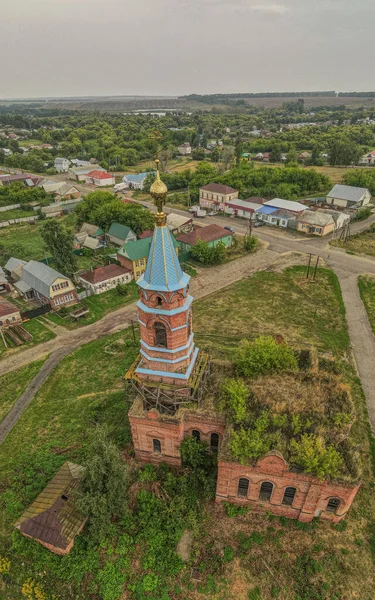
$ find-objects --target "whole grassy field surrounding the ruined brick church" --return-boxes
[0,267,375,600]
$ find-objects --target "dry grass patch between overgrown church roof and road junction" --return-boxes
[194,267,349,353]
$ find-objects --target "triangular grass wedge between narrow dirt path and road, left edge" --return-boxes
[0,357,47,421]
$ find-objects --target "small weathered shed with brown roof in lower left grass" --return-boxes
[15,461,87,556]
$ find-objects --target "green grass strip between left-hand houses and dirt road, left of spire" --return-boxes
[46,281,138,329]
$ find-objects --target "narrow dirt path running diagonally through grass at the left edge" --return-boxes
[0,346,73,444]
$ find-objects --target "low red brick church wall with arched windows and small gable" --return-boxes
[216,452,360,523]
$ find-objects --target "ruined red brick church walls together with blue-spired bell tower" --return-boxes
[125,161,359,522]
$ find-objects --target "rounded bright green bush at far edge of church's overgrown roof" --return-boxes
[234,336,298,377]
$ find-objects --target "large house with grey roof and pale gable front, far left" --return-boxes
[15,260,78,310]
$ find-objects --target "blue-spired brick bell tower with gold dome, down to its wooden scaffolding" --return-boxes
[125,160,209,415]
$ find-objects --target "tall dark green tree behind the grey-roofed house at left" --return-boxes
[40,219,77,277]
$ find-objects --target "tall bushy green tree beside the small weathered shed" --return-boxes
[77,427,130,542]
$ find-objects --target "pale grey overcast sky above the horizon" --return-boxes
[0,0,375,98]
